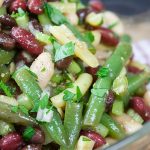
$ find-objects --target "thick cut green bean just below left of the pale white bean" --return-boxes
[12,67,42,108]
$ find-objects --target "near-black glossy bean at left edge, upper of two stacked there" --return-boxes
[0,15,17,28]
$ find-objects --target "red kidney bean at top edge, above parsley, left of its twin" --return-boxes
[9,0,27,12]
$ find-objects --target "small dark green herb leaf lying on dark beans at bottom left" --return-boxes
[23,127,35,141]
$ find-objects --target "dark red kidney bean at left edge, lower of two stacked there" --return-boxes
[0,32,15,50]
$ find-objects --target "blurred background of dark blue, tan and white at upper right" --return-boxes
[83,0,150,66]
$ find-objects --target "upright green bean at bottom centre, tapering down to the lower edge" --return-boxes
[64,102,83,150]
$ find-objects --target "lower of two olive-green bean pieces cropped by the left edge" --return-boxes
[0,65,10,82]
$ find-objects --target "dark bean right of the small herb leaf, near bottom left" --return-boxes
[30,128,45,144]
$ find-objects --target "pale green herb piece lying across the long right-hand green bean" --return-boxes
[91,89,108,98]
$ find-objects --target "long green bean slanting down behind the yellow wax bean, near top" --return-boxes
[44,3,96,53]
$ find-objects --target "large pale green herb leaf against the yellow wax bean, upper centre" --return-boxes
[55,42,75,62]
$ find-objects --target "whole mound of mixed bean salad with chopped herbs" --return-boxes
[0,0,150,150]
